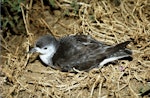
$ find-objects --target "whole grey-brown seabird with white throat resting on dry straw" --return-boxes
[29,35,132,72]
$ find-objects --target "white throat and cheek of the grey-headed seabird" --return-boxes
[39,45,56,66]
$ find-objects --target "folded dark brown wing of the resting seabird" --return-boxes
[53,35,107,71]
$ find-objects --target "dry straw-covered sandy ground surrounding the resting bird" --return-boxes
[0,0,150,98]
